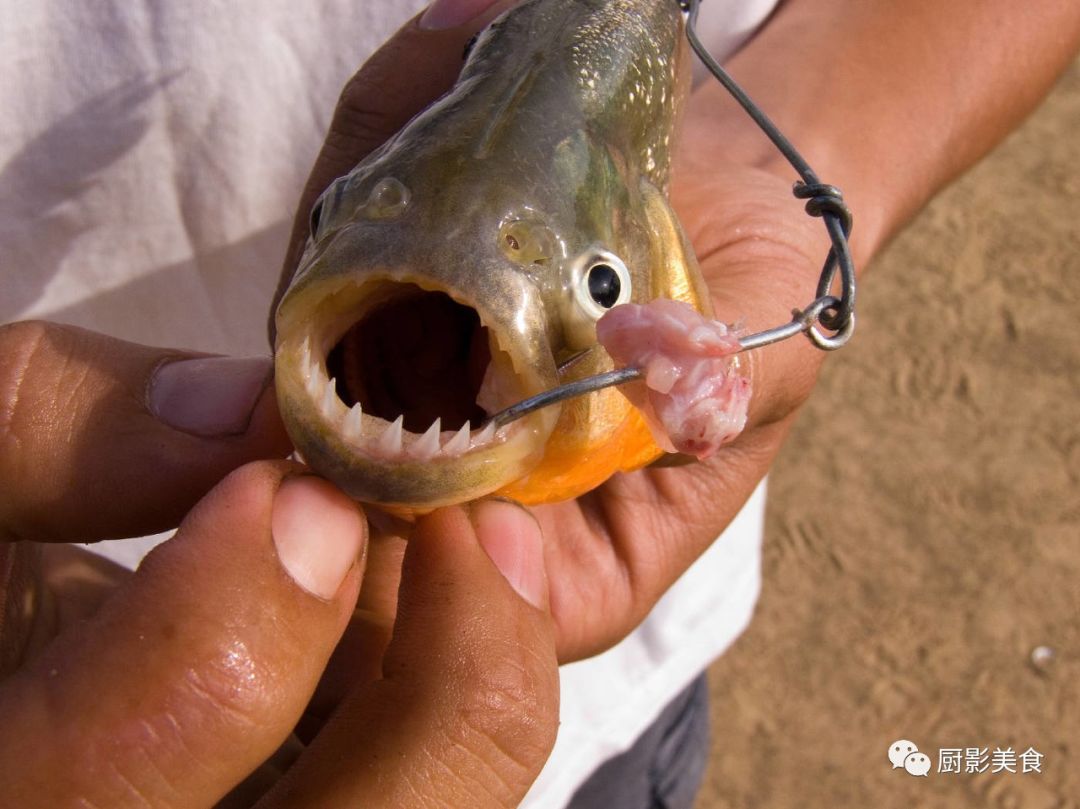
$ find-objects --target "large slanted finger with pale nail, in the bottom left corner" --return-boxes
[0,462,365,809]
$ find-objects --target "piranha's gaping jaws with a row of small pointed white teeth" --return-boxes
[275,271,559,513]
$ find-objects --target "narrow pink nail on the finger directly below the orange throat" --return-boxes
[469,500,548,609]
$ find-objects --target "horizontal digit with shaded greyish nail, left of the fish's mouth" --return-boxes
[0,323,289,542]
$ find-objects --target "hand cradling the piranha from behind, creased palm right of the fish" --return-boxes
[270,3,827,661]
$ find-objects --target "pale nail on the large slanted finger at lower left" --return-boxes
[270,475,367,601]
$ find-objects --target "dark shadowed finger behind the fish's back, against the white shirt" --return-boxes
[270,0,516,330]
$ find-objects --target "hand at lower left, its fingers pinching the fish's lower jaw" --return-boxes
[0,323,557,809]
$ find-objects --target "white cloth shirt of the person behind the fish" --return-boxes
[0,0,774,807]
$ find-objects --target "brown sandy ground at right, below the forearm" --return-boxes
[698,62,1080,809]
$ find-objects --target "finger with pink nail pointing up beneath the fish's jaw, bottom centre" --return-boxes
[260,501,558,807]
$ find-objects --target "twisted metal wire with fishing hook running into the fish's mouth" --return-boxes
[488,0,855,429]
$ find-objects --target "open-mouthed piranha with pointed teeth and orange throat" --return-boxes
[275,0,707,511]
